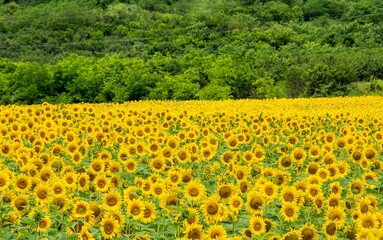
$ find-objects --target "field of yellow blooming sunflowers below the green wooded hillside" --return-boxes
[0,97,383,240]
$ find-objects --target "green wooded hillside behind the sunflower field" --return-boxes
[0,0,383,104]
